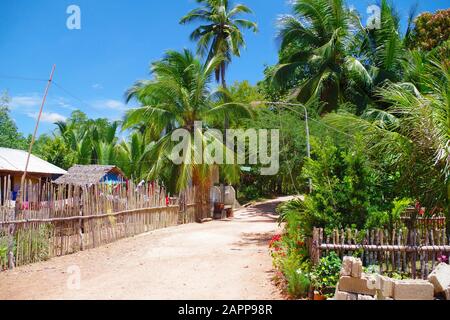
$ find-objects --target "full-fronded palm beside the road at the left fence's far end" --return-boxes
[123,50,250,220]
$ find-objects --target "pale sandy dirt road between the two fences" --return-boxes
[0,198,288,300]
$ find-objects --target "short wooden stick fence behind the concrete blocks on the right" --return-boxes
[309,227,450,279]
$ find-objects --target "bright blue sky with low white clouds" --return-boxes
[0,0,450,134]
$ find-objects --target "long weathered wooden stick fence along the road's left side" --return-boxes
[0,178,197,270]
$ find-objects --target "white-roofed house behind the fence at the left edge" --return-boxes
[0,148,67,200]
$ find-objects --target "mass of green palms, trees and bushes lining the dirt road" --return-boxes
[0,0,450,298]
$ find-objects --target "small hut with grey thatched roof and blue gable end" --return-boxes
[55,165,125,186]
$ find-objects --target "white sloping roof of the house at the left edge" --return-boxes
[0,148,67,175]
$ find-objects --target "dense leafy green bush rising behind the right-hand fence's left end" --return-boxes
[302,139,379,233]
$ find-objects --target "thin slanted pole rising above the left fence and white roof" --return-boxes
[8,65,56,269]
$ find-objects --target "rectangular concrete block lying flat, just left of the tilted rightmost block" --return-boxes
[394,280,434,300]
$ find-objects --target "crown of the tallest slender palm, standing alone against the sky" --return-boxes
[180,0,258,87]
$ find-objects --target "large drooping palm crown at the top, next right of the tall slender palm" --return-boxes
[273,0,371,113]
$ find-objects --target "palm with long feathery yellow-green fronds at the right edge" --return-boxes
[325,60,450,212]
